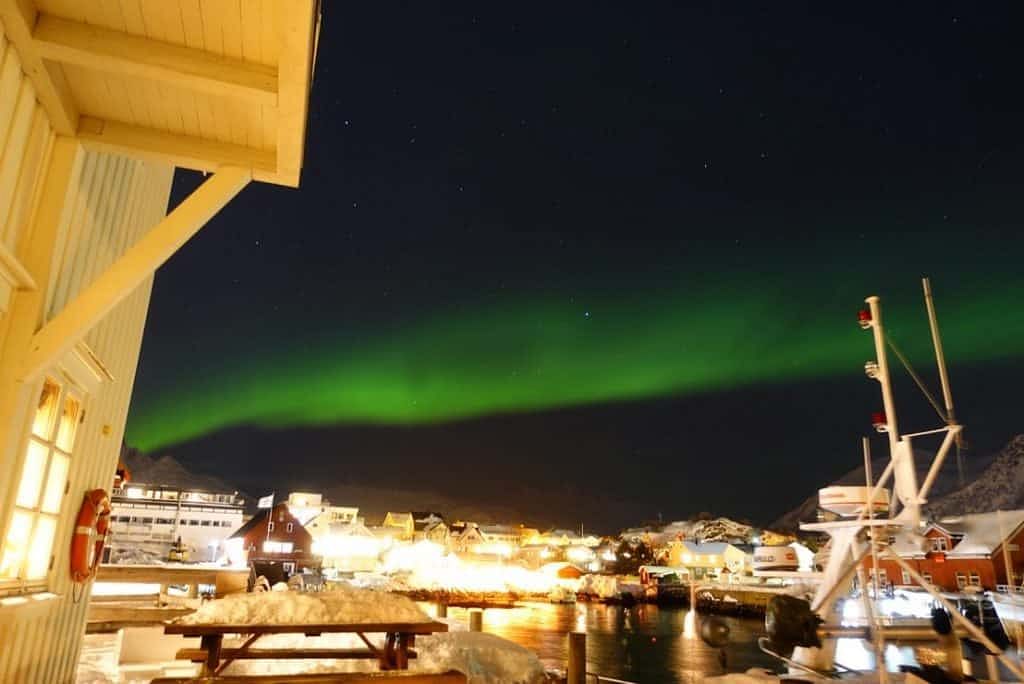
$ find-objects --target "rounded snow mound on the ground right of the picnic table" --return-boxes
[414,632,546,684]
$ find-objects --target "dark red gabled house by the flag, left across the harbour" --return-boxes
[230,503,321,575]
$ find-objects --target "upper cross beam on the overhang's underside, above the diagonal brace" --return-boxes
[33,14,278,106]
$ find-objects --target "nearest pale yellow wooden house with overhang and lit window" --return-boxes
[0,0,318,684]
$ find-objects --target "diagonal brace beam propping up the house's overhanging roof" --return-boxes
[20,167,252,380]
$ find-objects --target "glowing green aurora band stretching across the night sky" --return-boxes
[127,273,1024,451]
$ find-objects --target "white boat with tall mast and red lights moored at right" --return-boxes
[701,279,1024,681]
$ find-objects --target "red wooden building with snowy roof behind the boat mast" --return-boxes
[864,510,1024,591]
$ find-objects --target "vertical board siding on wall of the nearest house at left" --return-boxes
[0,18,173,684]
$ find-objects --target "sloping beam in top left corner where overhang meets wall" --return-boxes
[0,0,79,135]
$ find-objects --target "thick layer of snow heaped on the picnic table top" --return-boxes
[178,587,430,625]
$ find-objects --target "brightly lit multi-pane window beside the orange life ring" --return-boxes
[0,377,82,589]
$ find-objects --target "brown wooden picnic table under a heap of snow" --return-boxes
[164,622,447,677]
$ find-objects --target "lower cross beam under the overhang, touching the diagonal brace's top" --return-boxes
[78,117,276,182]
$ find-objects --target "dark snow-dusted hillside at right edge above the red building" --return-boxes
[928,434,1024,515]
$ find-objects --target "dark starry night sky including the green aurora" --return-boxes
[127,1,1024,528]
